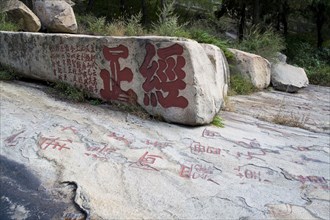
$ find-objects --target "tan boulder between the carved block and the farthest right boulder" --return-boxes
[230,49,271,89]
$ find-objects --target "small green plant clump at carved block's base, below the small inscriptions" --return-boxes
[51,82,88,102]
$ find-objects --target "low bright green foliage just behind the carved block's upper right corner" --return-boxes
[190,29,234,59]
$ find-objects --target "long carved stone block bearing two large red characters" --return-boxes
[0,32,224,125]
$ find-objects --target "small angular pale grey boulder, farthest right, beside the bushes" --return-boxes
[271,63,309,92]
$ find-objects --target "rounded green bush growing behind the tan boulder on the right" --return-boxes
[234,25,285,62]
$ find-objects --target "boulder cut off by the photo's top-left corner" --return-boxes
[0,0,41,32]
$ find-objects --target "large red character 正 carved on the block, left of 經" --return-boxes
[100,45,136,102]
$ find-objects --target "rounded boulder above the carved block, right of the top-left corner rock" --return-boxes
[33,0,78,33]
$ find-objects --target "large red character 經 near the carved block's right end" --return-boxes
[140,43,188,108]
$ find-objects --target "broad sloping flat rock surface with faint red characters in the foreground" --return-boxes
[0,82,330,220]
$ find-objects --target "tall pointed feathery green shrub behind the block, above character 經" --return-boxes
[151,2,189,38]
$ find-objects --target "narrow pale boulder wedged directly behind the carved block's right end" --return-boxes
[201,44,229,105]
